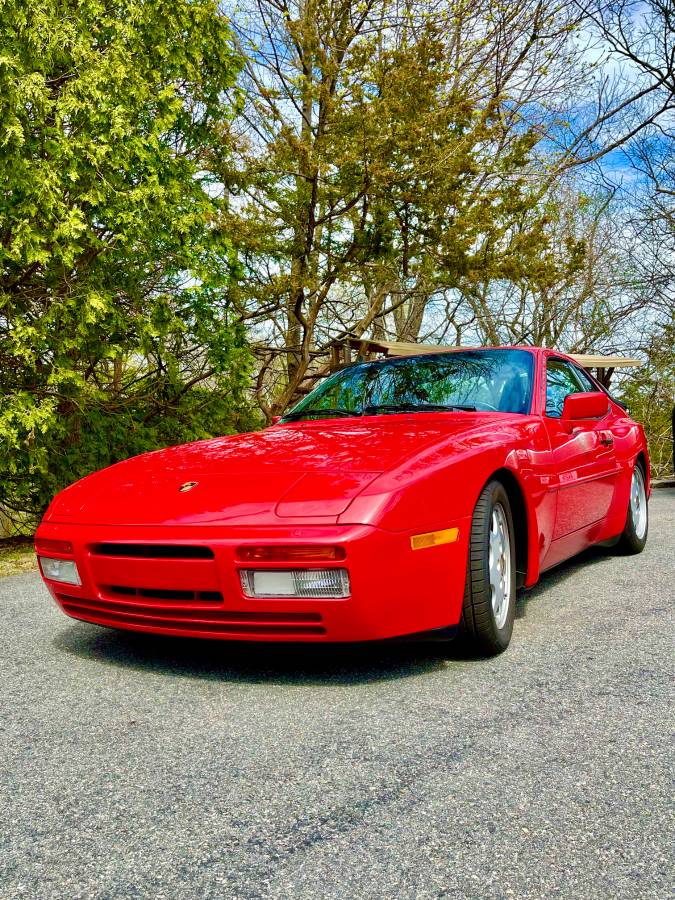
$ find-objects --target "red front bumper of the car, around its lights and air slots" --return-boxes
[36,522,468,642]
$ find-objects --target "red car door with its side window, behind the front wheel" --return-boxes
[544,356,617,541]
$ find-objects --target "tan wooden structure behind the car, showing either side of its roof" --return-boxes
[330,338,643,388]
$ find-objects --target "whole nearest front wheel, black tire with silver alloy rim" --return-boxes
[460,481,516,655]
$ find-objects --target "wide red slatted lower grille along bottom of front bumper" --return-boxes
[58,594,326,639]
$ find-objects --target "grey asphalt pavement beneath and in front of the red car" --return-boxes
[0,490,675,900]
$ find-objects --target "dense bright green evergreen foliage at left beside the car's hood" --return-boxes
[0,0,254,525]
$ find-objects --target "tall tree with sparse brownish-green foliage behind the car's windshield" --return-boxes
[223,0,567,417]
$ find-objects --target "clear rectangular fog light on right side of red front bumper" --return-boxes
[239,569,349,600]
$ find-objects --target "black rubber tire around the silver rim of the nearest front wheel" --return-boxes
[459,480,516,656]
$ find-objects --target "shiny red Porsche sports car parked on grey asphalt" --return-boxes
[35,347,650,653]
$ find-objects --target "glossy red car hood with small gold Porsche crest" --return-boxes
[45,413,492,525]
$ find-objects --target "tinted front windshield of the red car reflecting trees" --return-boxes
[284,350,534,421]
